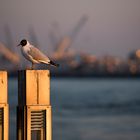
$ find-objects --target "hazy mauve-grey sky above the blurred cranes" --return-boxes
[0,0,140,56]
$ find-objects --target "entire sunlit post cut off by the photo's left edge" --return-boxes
[0,71,9,140]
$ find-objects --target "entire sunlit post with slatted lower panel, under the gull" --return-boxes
[17,70,52,140]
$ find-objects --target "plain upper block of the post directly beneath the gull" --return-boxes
[18,70,50,106]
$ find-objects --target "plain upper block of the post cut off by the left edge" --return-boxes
[0,71,7,104]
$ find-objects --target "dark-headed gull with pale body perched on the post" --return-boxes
[18,39,59,69]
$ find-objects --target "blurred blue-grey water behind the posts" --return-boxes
[9,79,140,140]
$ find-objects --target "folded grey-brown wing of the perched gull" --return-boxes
[28,46,50,63]
